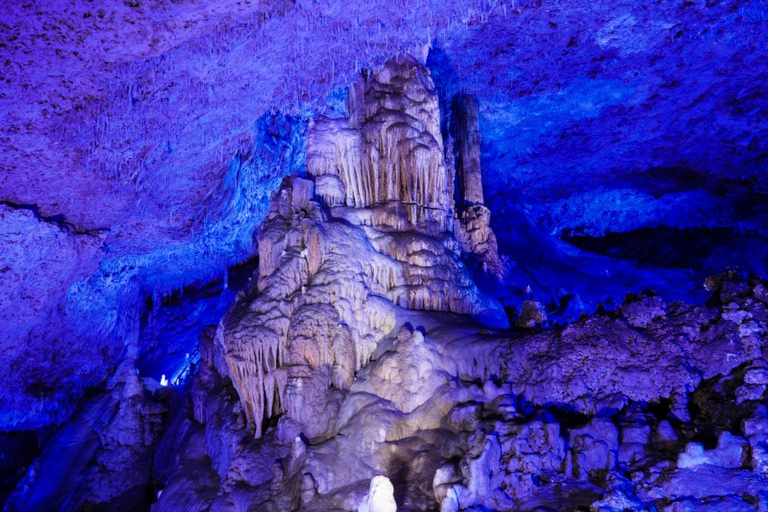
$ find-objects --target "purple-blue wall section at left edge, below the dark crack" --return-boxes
[0,204,112,429]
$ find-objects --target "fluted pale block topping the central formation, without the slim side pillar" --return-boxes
[307,58,453,233]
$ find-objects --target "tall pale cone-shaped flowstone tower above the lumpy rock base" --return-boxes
[218,59,506,437]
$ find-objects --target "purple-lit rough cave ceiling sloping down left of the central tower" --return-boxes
[0,1,508,432]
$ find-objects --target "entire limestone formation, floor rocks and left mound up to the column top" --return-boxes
[5,50,768,512]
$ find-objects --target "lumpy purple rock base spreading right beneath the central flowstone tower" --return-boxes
[130,273,768,511]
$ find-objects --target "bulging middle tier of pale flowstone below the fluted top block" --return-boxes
[217,174,505,438]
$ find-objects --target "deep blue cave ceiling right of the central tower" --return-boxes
[428,1,768,238]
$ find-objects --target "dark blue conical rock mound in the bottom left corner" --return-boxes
[4,364,166,512]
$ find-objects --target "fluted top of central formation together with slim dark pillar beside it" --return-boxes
[307,58,504,278]
